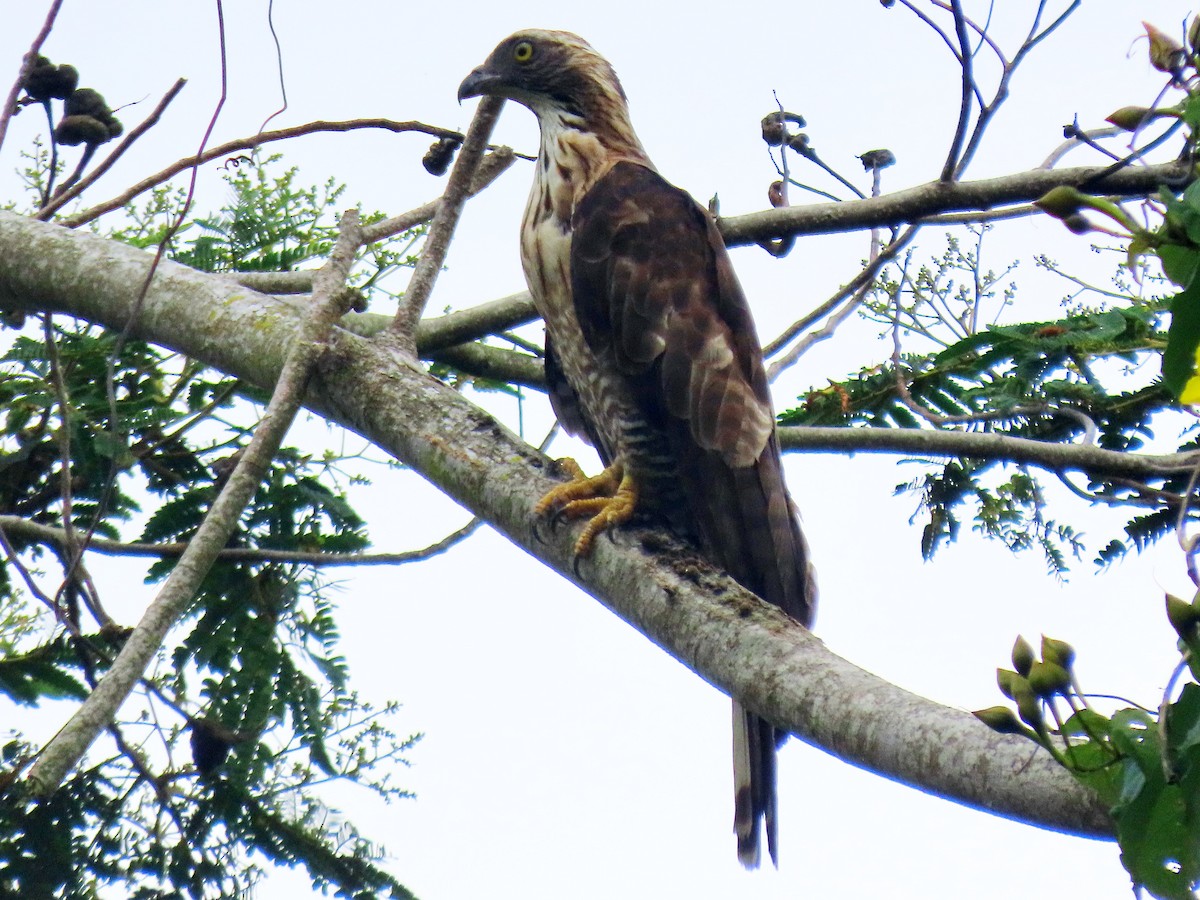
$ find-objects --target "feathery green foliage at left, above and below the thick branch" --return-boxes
[0,162,419,898]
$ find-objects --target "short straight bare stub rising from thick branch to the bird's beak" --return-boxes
[389,97,504,360]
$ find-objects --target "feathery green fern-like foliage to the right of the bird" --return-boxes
[780,229,1193,575]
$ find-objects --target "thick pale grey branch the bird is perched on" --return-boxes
[0,211,1110,836]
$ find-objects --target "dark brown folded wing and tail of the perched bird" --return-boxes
[571,162,816,864]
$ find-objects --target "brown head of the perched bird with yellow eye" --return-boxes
[458,29,625,121]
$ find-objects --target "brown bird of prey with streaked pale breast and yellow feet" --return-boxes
[458,30,816,866]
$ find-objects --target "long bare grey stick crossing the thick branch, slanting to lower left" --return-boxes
[28,210,361,797]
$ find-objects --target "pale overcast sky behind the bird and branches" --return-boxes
[7,0,1189,900]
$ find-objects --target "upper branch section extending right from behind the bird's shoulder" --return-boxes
[718,162,1193,247]
